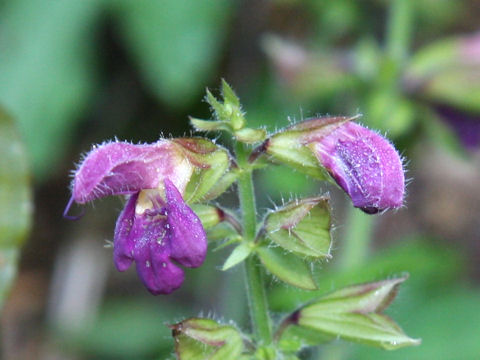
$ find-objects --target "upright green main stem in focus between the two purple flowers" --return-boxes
[235,142,272,345]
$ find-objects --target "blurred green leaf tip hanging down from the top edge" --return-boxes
[111,0,232,108]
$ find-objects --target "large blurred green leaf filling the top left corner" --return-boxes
[0,0,102,177]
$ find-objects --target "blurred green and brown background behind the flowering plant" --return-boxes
[0,0,480,360]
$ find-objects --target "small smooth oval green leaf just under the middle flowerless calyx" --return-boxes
[256,247,317,290]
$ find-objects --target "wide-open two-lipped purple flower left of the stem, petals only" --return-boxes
[67,140,207,295]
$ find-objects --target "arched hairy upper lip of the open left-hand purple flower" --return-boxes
[72,140,193,204]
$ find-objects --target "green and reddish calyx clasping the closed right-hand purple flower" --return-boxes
[257,116,359,180]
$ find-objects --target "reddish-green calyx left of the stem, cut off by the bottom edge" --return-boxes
[170,318,244,360]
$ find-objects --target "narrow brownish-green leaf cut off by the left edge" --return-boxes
[0,108,32,309]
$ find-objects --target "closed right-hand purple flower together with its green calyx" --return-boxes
[263,117,405,214]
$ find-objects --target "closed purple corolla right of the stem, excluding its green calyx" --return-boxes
[308,122,405,214]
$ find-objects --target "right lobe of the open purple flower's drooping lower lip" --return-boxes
[165,179,207,267]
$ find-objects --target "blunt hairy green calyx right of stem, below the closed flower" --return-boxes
[264,197,332,259]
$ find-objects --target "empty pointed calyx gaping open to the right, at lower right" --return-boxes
[288,276,420,350]
